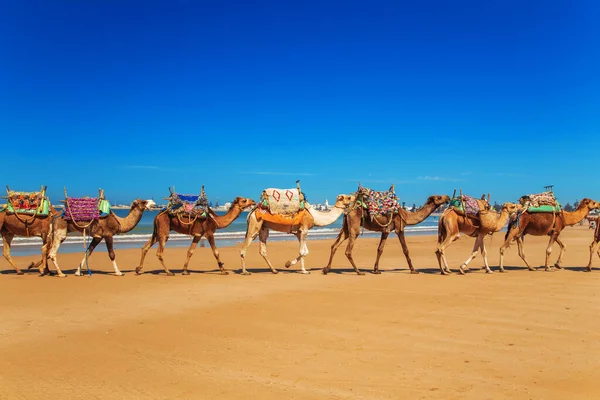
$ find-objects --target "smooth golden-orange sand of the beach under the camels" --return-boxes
[0,227,600,400]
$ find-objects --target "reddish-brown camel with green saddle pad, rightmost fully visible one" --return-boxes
[500,199,600,272]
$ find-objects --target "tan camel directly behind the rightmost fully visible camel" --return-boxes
[435,203,522,275]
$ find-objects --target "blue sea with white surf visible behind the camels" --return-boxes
[0,210,438,256]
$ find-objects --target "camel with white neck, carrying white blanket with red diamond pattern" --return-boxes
[240,194,354,275]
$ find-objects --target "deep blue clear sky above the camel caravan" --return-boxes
[0,0,600,204]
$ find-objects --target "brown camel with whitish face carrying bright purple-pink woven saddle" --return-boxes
[48,198,155,278]
